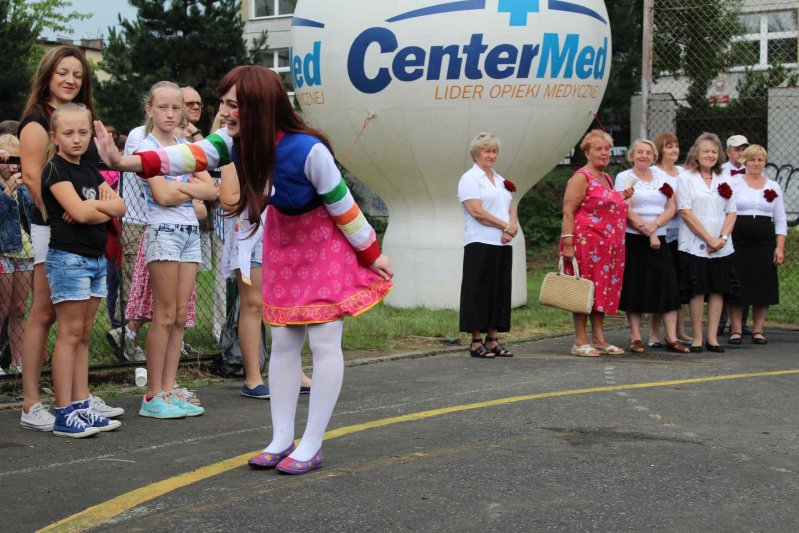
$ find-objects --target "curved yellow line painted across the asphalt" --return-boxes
[39,369,799,531]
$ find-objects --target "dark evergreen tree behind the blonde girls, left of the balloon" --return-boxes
[96,0,266,131]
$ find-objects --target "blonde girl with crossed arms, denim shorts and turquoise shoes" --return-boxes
[139,81,218,418]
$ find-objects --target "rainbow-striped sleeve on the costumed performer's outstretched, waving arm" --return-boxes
[137,128,233,178]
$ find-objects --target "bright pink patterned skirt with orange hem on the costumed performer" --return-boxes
[263,206,393,326]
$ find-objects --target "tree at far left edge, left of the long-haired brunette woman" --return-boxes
[0,0,89,120]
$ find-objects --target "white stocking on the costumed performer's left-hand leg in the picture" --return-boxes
[264,326,306,453]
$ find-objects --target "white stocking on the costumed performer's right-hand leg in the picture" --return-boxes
[294,320,344,461]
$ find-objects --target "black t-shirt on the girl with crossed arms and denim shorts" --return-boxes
[42,155,108,257]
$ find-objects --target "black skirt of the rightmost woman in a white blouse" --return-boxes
[727,216,780,307]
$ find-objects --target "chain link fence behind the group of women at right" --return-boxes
[644,0,799,324]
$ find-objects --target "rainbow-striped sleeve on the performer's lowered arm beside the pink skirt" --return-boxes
[321,174,380,266]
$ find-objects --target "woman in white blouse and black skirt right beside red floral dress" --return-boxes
[615,140,689,353]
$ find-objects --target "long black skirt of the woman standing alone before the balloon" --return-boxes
[460,242,513,333]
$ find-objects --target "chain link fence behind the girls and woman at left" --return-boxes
[0,164,231,374]
